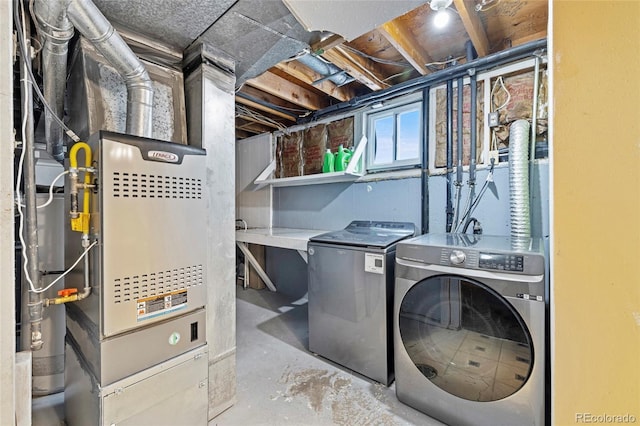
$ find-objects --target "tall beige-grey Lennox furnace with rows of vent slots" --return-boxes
[65,132,208,425]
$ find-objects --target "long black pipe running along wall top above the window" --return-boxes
[304,38,547,124]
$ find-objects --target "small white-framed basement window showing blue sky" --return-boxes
[366,102,422,171]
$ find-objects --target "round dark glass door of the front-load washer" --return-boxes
[398,275,534,402]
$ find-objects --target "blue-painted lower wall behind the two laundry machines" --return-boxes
[266,160,549,297]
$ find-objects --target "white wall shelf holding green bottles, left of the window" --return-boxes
[253,136,367,188]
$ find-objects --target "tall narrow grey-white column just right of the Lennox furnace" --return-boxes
[185,53,236,419]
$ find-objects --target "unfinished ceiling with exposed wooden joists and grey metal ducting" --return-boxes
[95,0,548,139]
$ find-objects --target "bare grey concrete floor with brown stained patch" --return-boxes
[32,287,442,426]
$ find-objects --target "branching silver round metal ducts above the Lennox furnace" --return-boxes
[35,0,153,161]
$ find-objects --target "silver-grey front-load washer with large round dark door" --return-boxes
[394,234,546,426]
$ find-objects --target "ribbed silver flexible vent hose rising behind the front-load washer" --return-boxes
[509,120,531,239]
